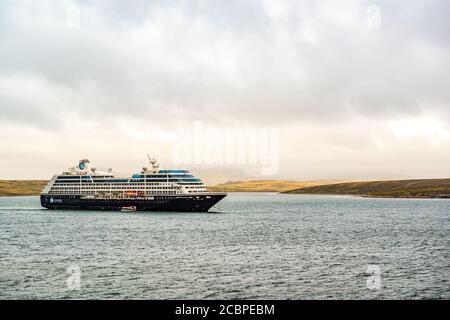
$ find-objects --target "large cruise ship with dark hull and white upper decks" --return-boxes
[41,157,227,212]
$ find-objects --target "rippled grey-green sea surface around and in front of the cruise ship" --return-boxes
[0,194,450,299]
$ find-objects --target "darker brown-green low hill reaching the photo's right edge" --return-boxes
[285,179,450,198]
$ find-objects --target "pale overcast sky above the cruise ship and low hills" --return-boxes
[0,0,450,179]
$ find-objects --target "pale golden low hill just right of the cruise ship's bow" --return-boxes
[207,180,348,192]
